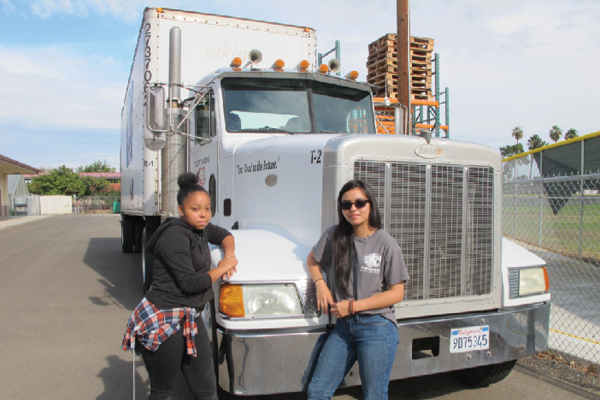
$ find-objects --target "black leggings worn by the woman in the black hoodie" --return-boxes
[136,318,218,400]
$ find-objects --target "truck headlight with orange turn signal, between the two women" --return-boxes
[219,284,304,318]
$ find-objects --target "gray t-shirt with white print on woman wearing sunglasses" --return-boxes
[312,226,409,323]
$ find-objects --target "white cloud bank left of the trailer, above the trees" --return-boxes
[0,46,126,130]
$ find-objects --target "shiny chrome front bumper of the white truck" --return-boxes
[217,303,550,395]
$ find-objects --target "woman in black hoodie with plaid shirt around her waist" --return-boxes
[122,173,237,400]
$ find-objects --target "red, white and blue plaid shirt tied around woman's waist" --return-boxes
[121,297,198,357]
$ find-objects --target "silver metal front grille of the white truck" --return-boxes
[354,161,494,300]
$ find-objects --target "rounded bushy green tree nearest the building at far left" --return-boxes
[28,165,85,196]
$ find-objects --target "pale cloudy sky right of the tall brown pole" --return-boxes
[404,0,600,149]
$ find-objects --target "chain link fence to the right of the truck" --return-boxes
[503,134,600,363]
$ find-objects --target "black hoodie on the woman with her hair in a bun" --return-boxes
[146,218,230,309]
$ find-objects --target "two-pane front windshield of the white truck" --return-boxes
[222,78,375,134]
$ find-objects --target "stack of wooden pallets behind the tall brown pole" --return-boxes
[367,33,434,101]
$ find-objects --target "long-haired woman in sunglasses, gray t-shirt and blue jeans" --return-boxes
[307,180,409,400]
